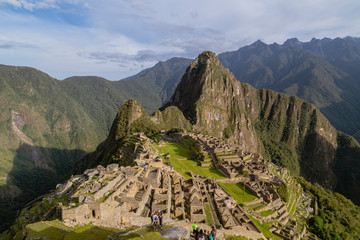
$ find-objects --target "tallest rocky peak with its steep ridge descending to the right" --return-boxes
[165,52,359,202]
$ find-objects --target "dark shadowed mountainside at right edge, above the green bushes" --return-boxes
[299,132,360,205]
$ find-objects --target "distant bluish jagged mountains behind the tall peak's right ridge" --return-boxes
[219,38,360,139]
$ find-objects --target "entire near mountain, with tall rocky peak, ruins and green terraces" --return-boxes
[1,52,360,239]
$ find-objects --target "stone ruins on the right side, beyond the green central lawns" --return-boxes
[183,134,299,235]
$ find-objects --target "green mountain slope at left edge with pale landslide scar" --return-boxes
[0,65,103,230]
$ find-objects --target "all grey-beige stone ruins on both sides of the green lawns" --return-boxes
[56,134,312,238]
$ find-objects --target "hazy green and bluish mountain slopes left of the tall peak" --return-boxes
[0,58,190,232]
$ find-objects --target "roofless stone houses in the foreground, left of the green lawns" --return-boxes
[57,161,263,238]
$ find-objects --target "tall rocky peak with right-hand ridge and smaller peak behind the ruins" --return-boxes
[77,49,360,207]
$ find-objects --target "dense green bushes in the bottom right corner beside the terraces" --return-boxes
[297,177,360,239]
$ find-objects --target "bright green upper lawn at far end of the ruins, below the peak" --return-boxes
[155,142,226,179]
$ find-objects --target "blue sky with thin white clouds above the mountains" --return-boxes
[0,0,360,80]
